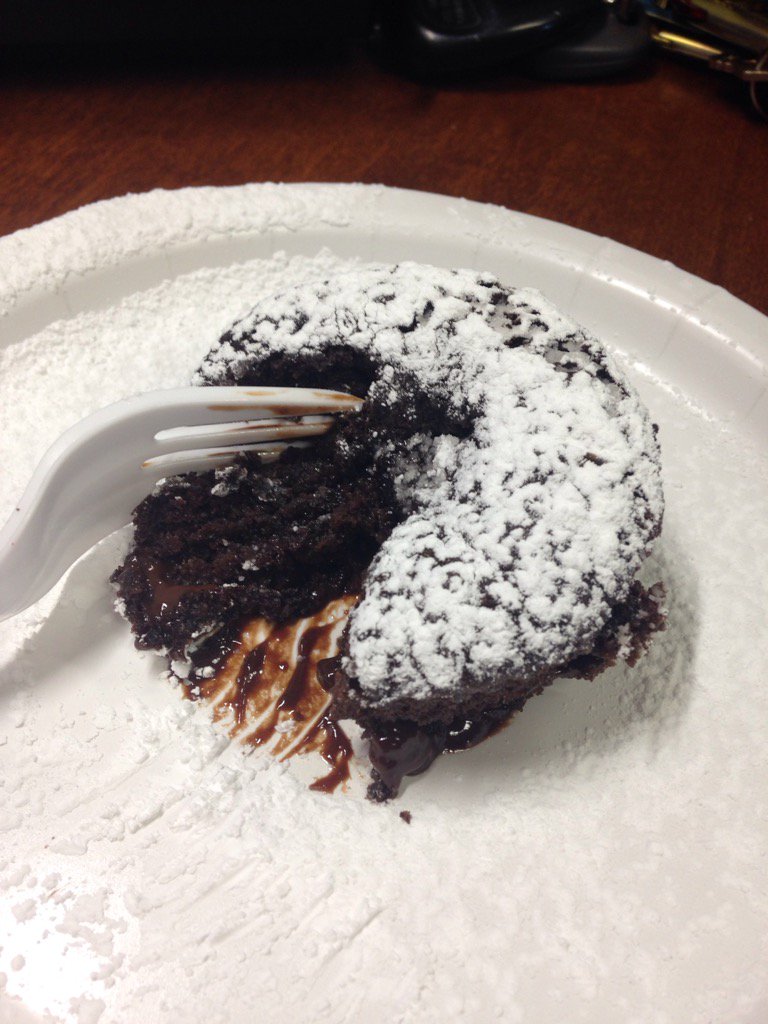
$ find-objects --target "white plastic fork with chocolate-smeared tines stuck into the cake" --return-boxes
[0,387,362,621]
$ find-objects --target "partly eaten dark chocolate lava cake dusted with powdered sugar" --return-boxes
[113,264,664,798]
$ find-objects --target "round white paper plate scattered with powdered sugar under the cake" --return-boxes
[0,185,768,1024]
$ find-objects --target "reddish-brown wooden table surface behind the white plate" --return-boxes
[0,46,768,312]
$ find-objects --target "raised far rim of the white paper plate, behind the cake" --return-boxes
[0,182,768,435]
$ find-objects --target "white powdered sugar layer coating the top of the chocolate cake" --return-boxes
[197,263,663,709]
